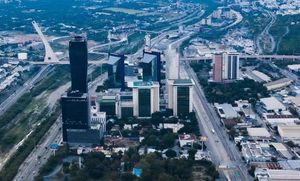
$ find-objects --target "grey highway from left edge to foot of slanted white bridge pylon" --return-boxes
[0,65,51,116]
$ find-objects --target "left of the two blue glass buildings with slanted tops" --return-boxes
[108,54,125,90]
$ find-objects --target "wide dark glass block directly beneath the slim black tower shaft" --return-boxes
[61,95,89,141]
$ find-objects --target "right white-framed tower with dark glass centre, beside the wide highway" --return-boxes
[168,79,195,116]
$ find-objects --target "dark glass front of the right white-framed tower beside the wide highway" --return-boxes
[177,87,190,115]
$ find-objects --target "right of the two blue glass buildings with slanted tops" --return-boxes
[141,51,161,83]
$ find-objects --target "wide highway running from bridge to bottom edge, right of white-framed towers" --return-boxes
[183,64,250,181]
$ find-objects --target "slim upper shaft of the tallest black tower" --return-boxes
[69,36,88,93]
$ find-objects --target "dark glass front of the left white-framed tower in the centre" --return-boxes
[138,89,151,117]
